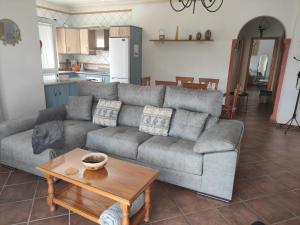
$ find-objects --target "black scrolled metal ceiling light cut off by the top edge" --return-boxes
[170,0,223,14]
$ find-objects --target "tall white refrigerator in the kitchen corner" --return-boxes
[109,38,130,83]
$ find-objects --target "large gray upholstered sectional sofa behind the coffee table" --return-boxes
[0,82,244,201]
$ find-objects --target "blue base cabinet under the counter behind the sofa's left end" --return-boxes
[45,83,79,108]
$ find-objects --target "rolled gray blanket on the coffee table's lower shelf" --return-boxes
[99,194,144,225]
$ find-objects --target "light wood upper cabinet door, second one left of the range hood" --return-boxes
[66,29,81,54]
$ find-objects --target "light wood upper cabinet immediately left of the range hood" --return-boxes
[79,29,96,55]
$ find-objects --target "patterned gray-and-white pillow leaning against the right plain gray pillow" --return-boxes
[139,105,173,136]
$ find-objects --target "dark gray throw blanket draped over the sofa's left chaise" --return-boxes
[32,107,66,154]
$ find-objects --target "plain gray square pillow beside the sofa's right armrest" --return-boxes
[169,109,208,141]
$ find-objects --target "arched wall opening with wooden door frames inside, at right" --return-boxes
[227,16,290,119]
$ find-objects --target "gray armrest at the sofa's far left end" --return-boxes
[0,116,37,142]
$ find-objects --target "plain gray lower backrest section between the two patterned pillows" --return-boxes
[118,105,144,127]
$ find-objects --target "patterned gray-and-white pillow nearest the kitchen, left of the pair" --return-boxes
[93,99,122,127]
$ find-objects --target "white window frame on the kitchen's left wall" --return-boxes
[38,17,59,76]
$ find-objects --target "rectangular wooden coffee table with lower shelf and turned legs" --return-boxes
[37,149,159,225]
